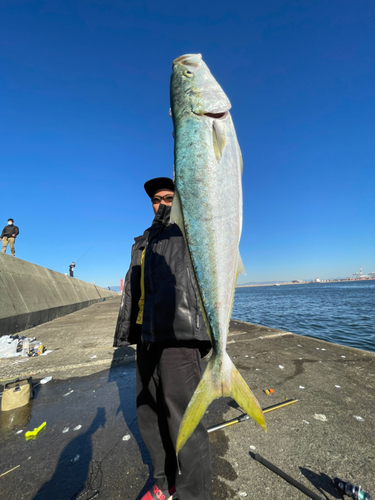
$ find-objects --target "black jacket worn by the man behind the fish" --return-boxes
[114,204,210,351]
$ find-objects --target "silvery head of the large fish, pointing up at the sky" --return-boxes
[171,54,231,117]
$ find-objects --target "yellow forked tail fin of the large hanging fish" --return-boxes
[176,353,267,455]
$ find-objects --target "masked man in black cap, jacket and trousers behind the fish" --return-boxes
[114,177,211,500]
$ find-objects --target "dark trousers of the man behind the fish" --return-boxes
[137,343,211,500]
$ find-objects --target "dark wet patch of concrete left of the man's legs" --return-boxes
[0,348,232,500]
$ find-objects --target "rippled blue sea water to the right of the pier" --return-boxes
[232,280,375,352]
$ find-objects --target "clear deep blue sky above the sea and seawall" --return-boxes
[0,0,375,286]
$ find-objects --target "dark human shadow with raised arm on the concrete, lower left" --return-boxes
[33,408,106,500]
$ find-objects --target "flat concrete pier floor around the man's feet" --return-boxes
[0,298,375,500]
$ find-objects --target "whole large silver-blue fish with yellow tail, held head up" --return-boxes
[171,54,266,454]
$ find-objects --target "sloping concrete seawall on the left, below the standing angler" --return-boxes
[0,254,118,336]
